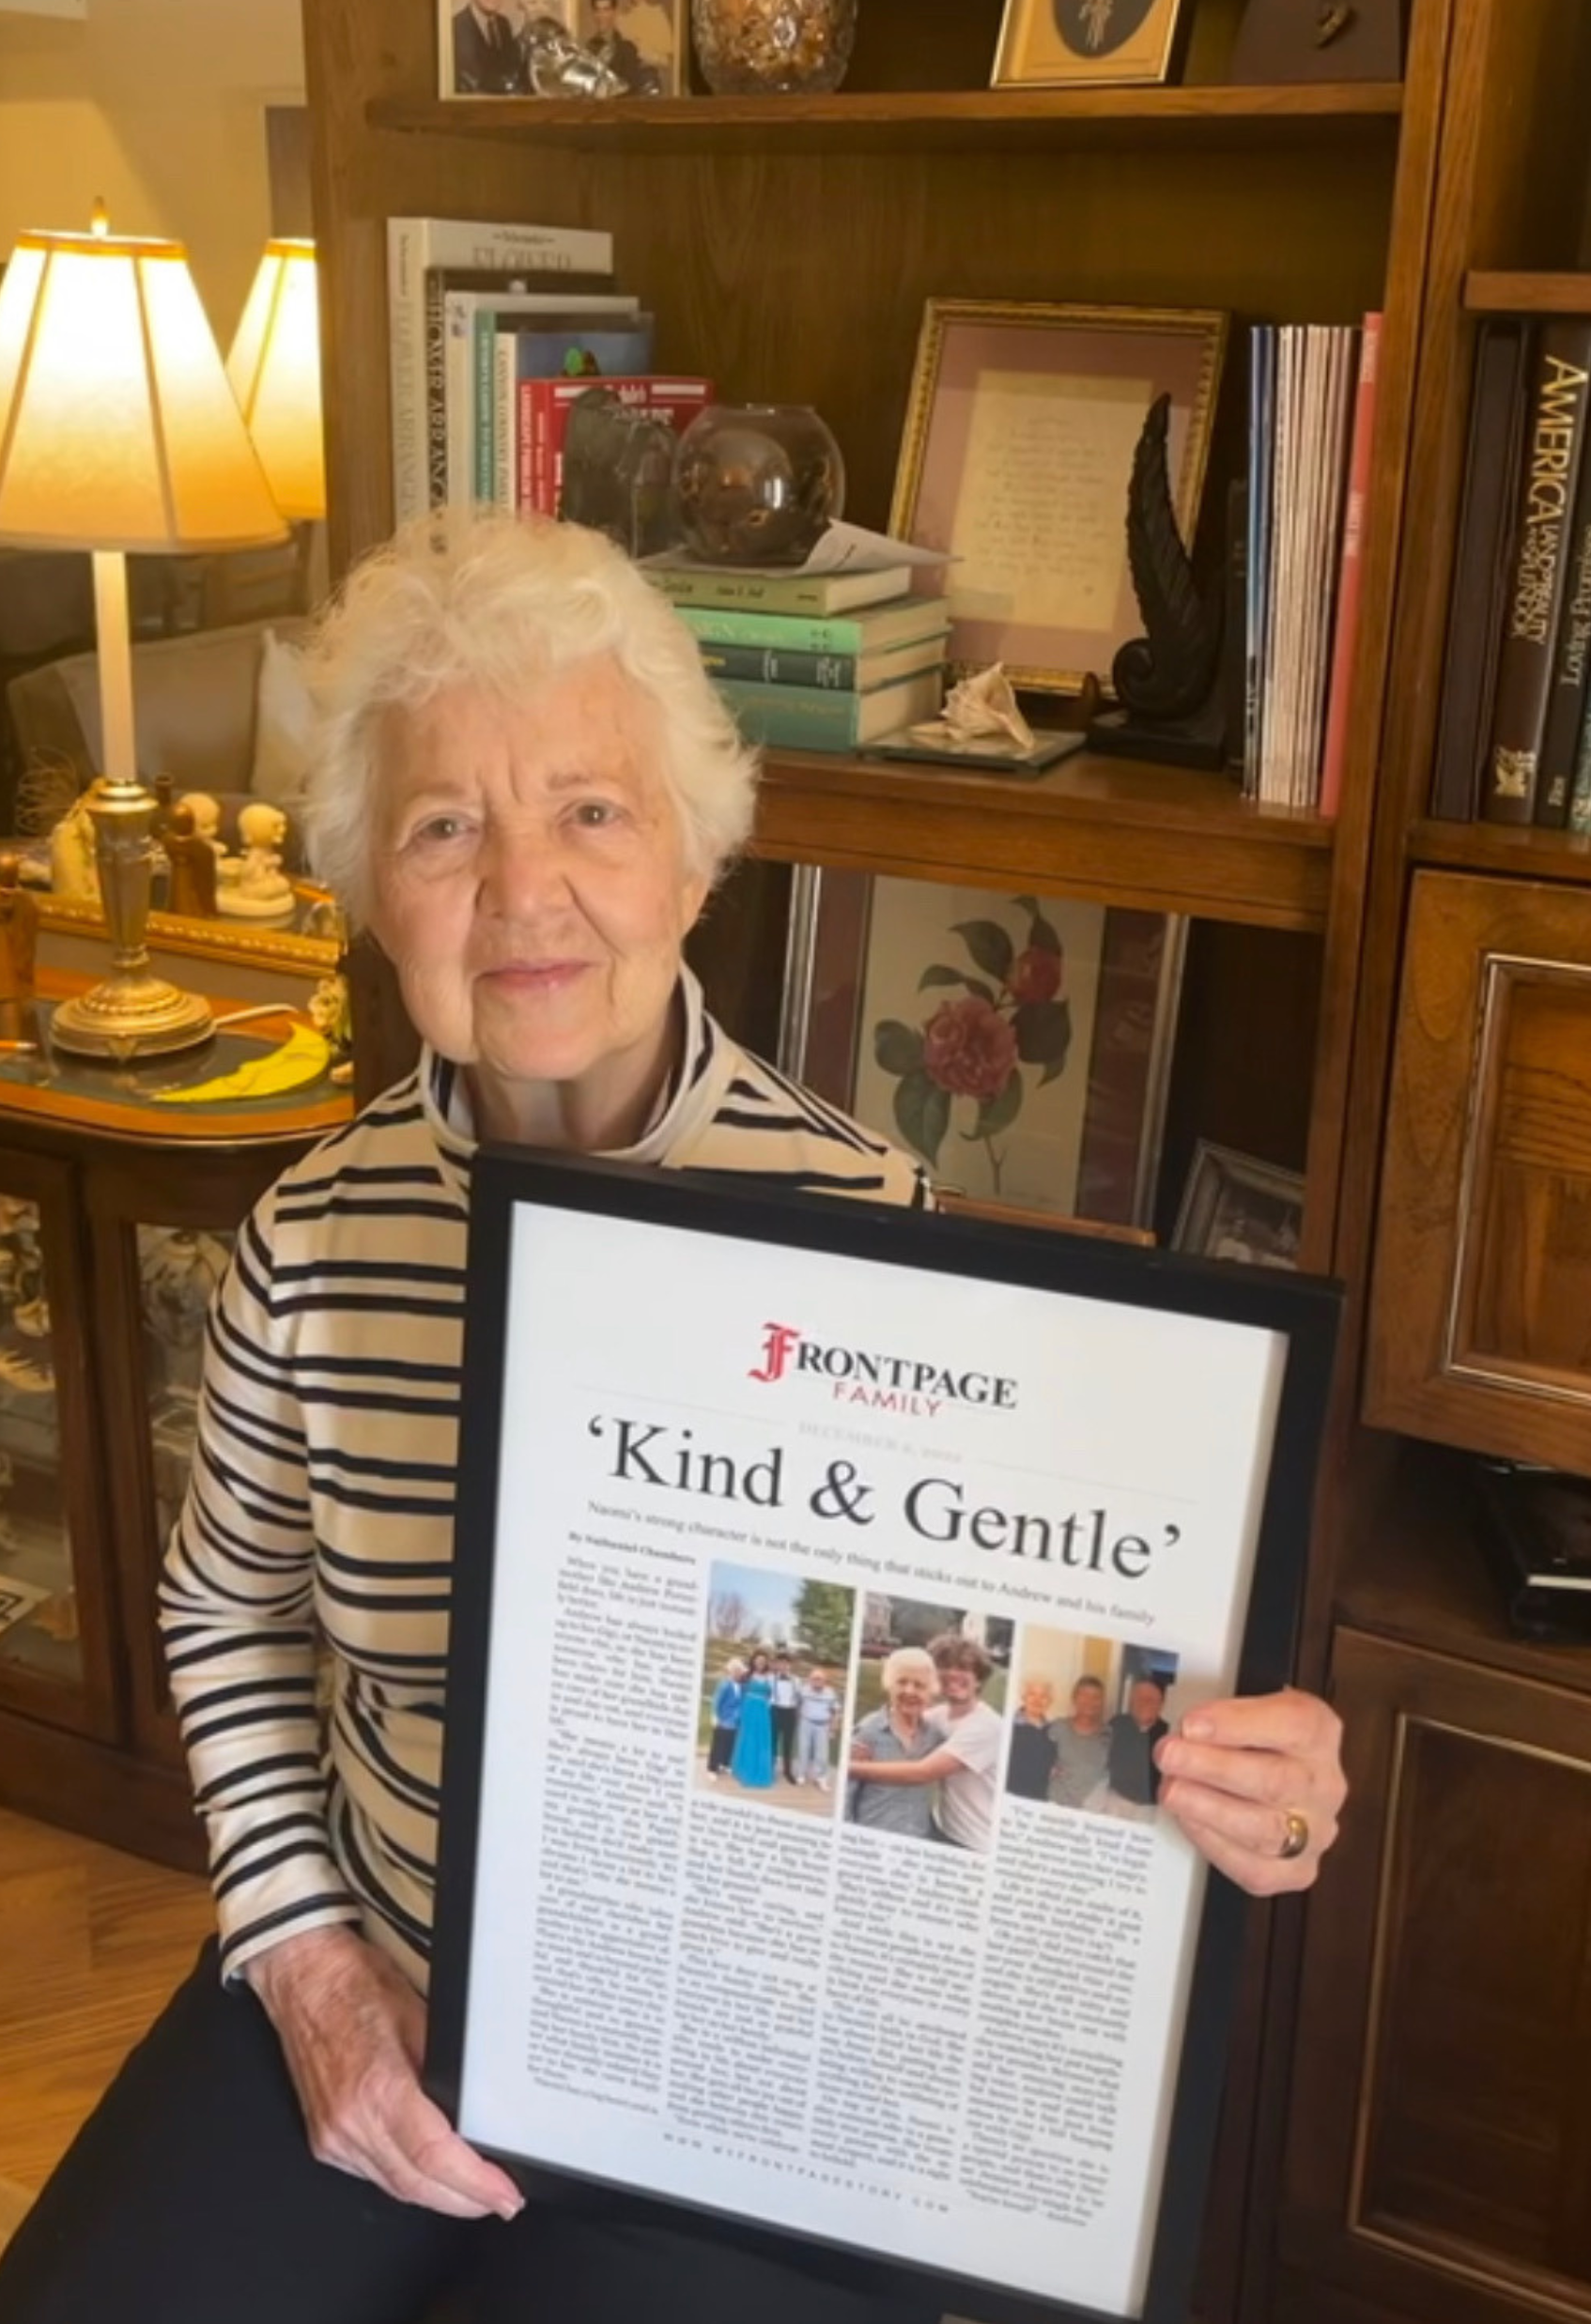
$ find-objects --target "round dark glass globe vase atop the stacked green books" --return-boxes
[674,405,844,564]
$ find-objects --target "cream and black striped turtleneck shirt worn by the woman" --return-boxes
[161,974,926,1990]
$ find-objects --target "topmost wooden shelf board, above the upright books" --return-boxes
[365,82,1402,153]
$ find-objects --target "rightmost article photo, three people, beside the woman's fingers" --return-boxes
[1005,1624,1177,1824]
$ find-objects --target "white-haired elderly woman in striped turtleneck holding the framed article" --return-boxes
[0,518,1340,2324]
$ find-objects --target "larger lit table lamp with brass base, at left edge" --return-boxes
[0,216,286,1060]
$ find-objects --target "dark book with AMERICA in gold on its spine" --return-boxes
[1482,316,1591,823]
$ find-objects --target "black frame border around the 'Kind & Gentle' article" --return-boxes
[424,1148,1340,2324]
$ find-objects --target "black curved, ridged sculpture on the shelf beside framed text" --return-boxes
[1089,395,1226,767]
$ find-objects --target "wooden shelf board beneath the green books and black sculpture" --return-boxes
[753,750,1333,931]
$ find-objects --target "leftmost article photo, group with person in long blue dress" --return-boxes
[696,1564,856,1815]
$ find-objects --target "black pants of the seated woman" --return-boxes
[0,1946,937,2324]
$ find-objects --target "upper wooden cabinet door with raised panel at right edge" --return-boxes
[1366,871,1591,1473]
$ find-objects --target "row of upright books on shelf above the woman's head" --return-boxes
[386,219,712,523]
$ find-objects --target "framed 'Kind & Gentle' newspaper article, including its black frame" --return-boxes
[425,1153,1337,2324]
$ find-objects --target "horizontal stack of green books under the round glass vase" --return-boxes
[646,560,949,750]
